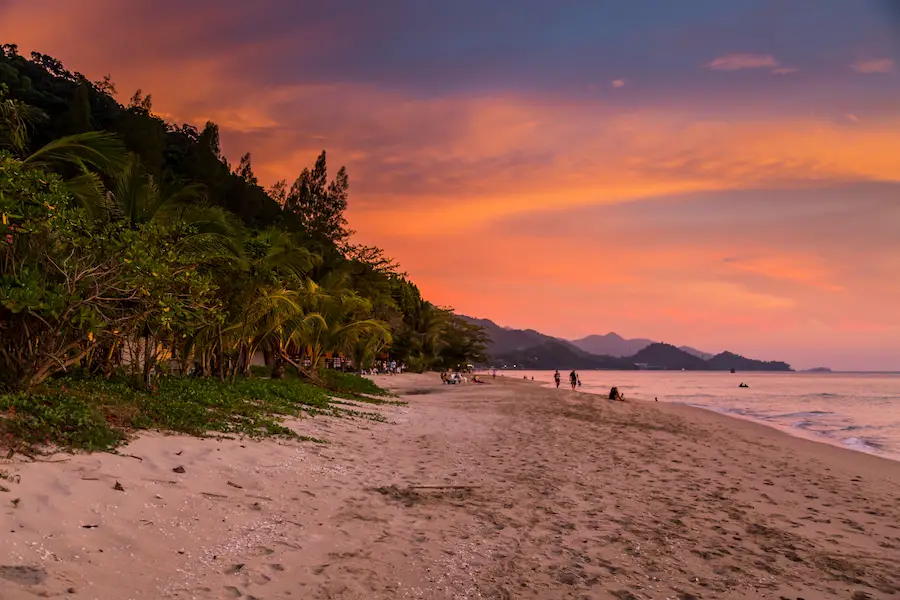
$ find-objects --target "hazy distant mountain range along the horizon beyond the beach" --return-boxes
[461,315,791,371]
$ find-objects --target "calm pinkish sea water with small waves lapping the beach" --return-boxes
[498,371,900,460]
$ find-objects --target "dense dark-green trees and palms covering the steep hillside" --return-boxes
[0,45,485,394]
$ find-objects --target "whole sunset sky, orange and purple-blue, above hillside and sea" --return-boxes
[0,0,900,370]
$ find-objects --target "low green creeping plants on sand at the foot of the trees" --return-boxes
[0,375,386,451]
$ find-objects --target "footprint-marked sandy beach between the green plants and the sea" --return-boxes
[0,375,900,600]
